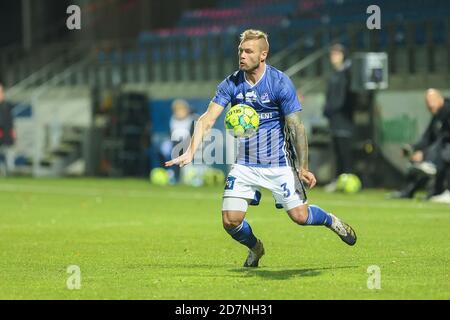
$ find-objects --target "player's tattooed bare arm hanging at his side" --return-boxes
[286,111,316,188]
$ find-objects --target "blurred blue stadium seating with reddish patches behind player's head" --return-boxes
[95,0,450,79]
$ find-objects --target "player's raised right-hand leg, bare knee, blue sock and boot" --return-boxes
[287,203,356,246]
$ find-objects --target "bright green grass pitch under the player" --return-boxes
[0,178,450,300]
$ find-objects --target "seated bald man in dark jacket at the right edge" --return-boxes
[392,89,450,201]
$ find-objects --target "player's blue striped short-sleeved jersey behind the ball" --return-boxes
[212,65,302,167]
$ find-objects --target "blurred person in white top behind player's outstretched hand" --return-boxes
[160,99,197,182]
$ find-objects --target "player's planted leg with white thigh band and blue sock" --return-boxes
[222,197,264,267]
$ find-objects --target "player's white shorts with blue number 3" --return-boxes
[223,164,307,210]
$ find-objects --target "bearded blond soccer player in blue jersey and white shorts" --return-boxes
[166,29,356,267]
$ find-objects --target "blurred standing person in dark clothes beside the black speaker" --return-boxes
[323,44,354,191]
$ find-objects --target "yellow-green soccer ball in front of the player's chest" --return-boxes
[225,104,259,138]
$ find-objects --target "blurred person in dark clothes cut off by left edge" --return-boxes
[0,81,15,175]
